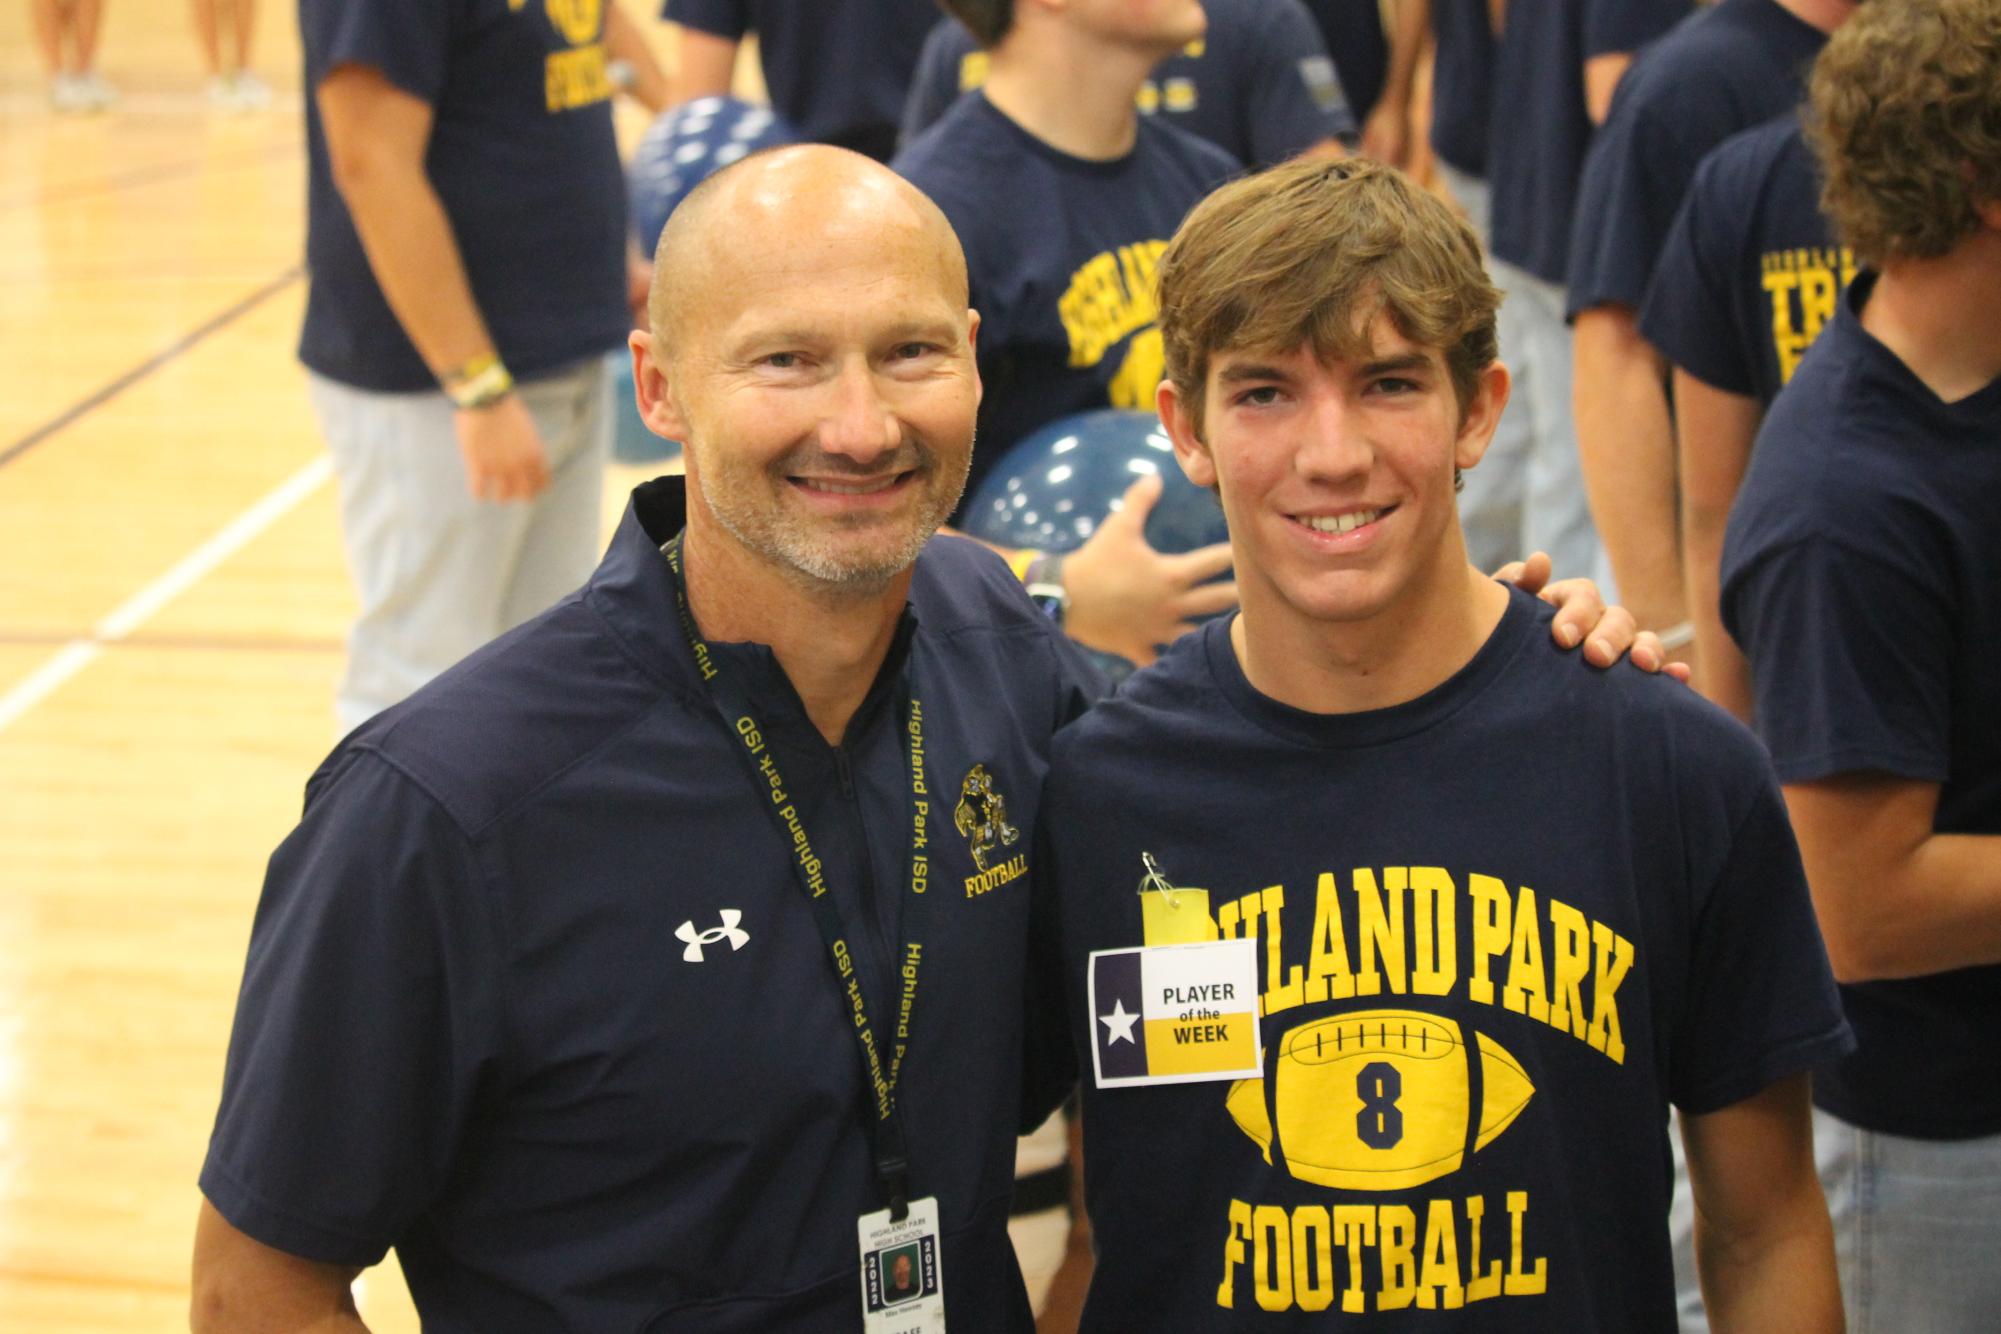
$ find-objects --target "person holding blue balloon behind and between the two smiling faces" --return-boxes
[890,0,1239,662]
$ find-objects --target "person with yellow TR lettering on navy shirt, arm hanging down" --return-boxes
[1639,112,1855,722]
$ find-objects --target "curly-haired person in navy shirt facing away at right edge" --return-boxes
[1723,0,2001,1332]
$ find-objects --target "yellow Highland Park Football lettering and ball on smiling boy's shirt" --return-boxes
[1143,866,1635,1314]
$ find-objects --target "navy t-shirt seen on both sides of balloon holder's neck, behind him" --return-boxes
[902,0,1355,166]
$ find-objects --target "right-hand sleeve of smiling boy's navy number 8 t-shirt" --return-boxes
[1669,760,1855,1114]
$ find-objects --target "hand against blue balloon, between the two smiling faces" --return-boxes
[1063,476,1237,666]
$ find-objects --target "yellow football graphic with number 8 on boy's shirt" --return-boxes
[1225,1010,1535,1190]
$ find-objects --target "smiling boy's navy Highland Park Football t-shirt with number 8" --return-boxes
[1043,592,1849,1334]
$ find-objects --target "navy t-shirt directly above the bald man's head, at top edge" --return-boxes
[662,0,938,162]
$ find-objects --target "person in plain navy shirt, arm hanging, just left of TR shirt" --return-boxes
[1567,0,1855,652]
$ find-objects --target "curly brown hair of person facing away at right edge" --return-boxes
[1807,0,2001,264]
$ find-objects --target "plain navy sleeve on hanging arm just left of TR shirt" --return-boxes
[1567,90,1695,316]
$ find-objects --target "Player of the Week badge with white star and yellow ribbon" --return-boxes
[1085,854,1263,1088]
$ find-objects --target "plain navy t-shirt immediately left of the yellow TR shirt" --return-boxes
[1567,0,1827,316]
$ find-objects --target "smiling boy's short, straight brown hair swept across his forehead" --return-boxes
[1161,158,1501,430]
